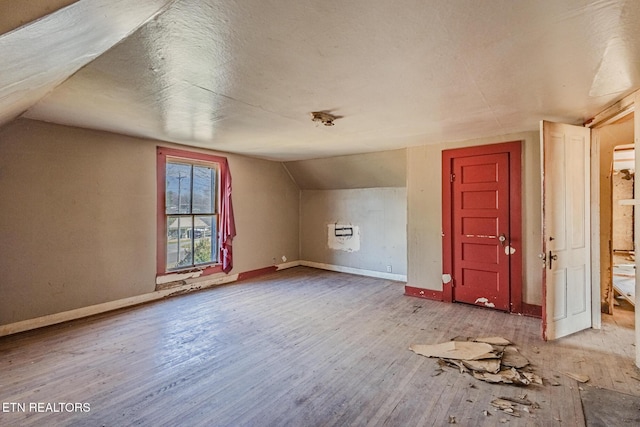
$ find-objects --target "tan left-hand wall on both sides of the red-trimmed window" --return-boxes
[0,120,299,325]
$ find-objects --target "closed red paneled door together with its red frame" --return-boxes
[442,141,524,316]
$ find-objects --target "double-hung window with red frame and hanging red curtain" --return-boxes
[157,148,235,275]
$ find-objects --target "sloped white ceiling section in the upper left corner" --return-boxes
[0,0,176,129]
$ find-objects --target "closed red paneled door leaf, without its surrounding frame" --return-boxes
[451,153,510,311]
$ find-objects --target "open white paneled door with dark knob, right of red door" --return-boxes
[540,121,591,340]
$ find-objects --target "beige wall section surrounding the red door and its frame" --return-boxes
[407,132,542,305]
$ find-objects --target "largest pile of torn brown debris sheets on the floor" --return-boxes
[409,337,542,386]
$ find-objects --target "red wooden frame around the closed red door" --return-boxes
[442,141,524,313]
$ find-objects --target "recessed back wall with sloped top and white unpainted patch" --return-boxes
[285,149,407,280]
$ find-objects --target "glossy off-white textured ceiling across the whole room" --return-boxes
[0,0,640,160]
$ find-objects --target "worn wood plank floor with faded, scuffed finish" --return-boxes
[0,267,640,427]
